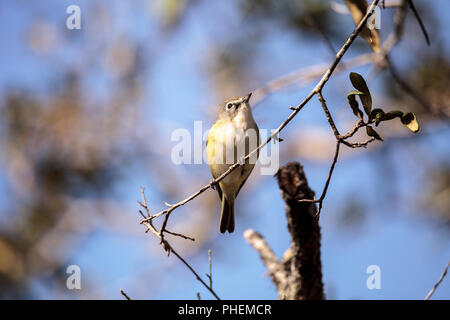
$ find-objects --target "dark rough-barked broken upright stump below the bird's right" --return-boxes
[276,162,325,300]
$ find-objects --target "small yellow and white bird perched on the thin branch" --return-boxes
[206,93,259,233]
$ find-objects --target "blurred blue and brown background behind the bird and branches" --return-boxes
[0,0,450,299]
